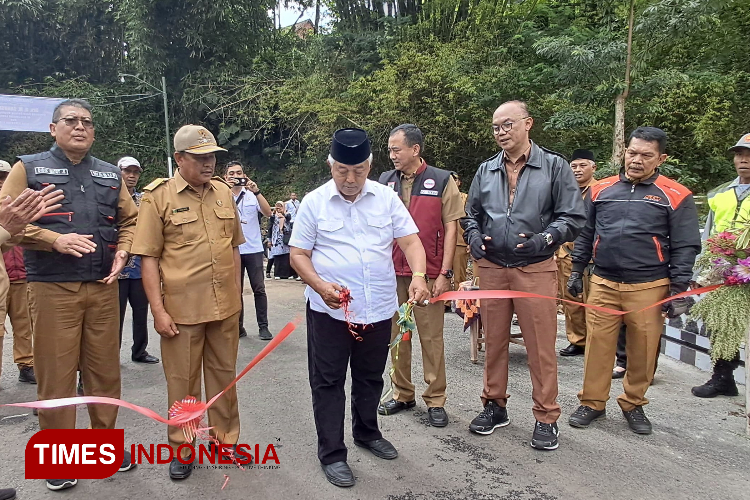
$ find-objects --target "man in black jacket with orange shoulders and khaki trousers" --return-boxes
[567,127,701,434]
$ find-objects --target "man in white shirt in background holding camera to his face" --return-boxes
[224,161,273,340]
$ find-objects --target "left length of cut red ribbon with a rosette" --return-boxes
[6,318,299,430]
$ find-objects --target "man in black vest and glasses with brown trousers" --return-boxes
[0,99,138,490]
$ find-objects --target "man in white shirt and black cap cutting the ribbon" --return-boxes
[289,129,430,487]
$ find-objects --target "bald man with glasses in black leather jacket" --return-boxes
[461,101,586,450]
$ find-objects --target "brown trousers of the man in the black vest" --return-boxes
[29,281,120,429]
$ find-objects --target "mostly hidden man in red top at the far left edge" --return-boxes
[0,161,36,384]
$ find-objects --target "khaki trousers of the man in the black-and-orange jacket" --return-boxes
[578,275,669,411]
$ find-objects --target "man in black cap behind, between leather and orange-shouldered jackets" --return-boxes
[557,149,596,356]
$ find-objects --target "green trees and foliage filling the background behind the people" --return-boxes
[0,0,750,199]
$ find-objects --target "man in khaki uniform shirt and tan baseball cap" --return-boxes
[133,125,245,479]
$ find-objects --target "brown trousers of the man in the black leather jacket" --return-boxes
[476,259,560,424]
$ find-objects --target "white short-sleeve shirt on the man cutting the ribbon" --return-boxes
[289,179,418,324]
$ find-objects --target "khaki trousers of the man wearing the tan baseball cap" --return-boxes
[164,311,240,457]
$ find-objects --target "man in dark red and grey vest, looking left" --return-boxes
[378,124,465,427]
